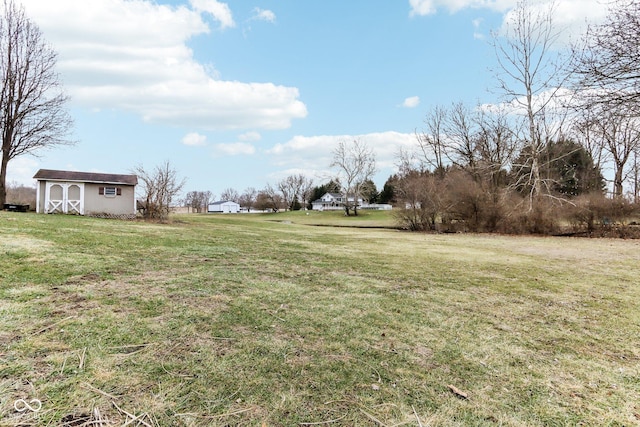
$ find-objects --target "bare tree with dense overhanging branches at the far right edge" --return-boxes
[573,0,640,198]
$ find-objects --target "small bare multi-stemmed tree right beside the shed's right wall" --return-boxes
[134,161,185,220]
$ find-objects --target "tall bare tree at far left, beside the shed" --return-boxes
[0,0,72,205]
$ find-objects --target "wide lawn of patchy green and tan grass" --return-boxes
[0,212,640,426]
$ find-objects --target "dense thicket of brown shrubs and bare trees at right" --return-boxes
[387,0,640,233]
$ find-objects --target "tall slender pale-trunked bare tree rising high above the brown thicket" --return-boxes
[493,0,569,208]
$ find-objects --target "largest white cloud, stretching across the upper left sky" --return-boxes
[23,0,307,130]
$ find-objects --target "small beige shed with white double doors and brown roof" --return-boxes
[34,169,138,219]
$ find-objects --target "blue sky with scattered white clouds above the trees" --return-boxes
[8,0,606,195]
